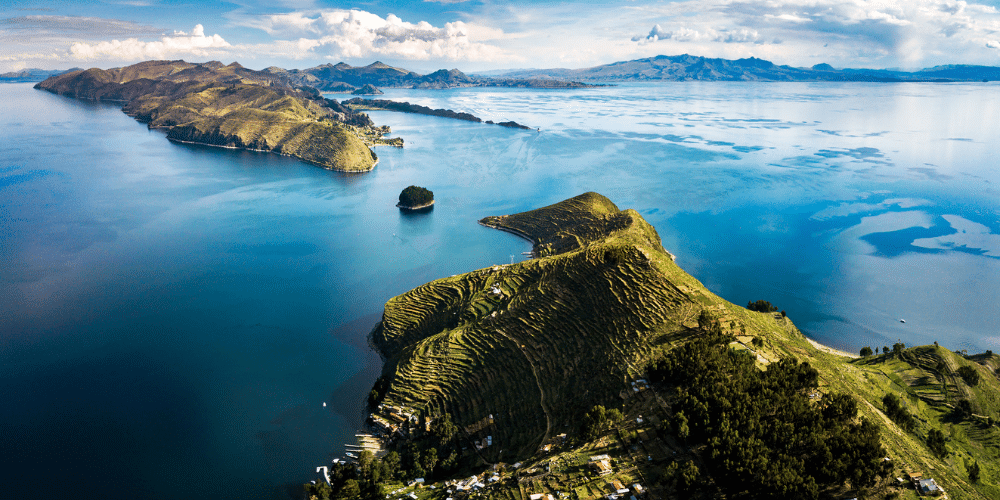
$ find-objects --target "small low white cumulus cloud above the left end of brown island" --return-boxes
[69,24,231,61]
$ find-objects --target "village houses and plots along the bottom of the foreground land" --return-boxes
[317,372,948,500]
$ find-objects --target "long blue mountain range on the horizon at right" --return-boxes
[491,54,1000,82]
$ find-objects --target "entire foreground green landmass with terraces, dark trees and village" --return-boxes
[305,193,1000,500]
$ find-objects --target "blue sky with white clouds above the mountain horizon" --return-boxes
[0,0,1000,73]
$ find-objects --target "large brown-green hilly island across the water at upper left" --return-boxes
[35,61,402,172]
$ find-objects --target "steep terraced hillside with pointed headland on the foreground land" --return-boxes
[373,193,790,462]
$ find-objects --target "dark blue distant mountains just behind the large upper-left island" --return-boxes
[264,61,590,92]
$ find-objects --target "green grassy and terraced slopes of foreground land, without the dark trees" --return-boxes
[374,193,1000,499]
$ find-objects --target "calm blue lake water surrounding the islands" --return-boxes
[0,83,1000,499]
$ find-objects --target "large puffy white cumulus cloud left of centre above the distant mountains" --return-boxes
[239,9,510,61]
